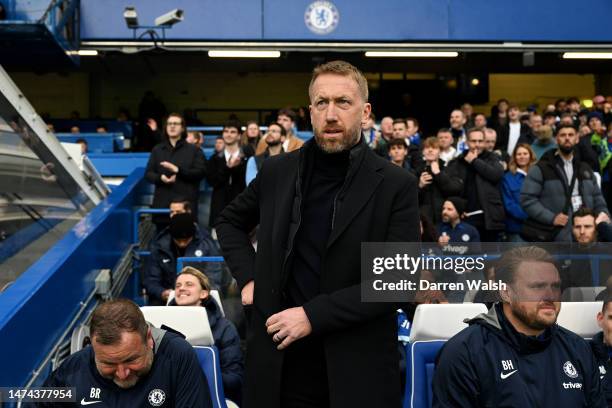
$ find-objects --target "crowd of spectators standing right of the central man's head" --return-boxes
[363,95,612,242]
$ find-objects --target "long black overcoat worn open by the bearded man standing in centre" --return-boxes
[216,138,419,408]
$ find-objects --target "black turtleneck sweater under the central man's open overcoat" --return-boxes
[287,143,350,306]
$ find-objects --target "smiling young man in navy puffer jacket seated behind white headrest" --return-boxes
[170,266,244,404]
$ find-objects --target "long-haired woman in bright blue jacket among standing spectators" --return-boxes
[502,143,536,242]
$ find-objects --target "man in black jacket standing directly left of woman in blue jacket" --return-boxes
[448,129,505,242]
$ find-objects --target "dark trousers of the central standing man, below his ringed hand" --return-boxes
[280,337,329,408]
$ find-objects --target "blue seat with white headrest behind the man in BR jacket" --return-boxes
[140,306,227,408]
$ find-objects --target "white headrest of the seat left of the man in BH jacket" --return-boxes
[410,303,487,343]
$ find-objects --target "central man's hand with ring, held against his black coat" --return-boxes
[266,307,312,350]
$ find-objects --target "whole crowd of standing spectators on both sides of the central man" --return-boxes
[47,92,612,242]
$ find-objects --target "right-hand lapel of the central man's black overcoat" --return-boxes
[327,152,383,248]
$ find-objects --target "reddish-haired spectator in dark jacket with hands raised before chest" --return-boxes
[414,137,461,224]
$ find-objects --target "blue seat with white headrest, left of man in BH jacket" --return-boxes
[403,303,487,408]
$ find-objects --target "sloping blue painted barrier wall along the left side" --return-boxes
[0,169,144,386]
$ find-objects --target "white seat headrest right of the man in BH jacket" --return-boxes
[557,302,603,339]
